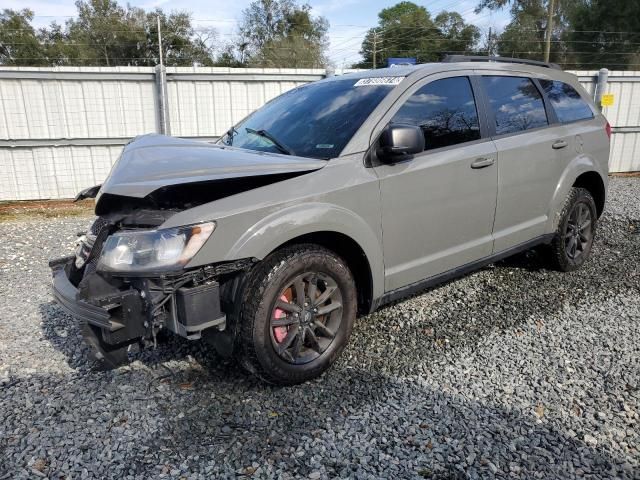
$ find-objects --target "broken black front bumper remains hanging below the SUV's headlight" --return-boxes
[49,256,226,345]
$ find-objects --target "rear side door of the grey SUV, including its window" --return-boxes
[480,72,571,253]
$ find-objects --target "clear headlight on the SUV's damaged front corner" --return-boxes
[98,222,216,272]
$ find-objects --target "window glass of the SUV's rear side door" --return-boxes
[482,76,549,135]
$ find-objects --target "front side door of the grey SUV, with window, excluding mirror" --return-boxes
[374,71,497,291]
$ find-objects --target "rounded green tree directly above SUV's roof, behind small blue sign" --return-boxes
[354,2,480,68]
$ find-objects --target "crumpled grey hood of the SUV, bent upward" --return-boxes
[98,134,327,199]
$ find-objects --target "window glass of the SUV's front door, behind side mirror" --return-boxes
[391,77,480,150]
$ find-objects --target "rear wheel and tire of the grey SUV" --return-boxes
[551,188,598,272]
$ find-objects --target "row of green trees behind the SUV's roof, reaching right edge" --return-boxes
[357,0,640,70]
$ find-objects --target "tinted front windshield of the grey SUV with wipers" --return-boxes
[222,78,399,159]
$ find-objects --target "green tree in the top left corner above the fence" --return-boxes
[0,9,47,66]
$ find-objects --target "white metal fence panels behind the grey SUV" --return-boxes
[0,67,640,201]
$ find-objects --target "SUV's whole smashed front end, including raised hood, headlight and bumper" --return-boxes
[50,135,326,366]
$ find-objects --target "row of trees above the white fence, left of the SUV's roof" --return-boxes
[0,0,329,68]
